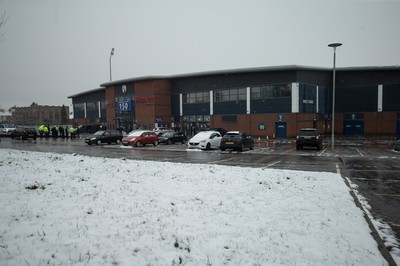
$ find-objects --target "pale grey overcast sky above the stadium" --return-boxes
[0,0,400,109]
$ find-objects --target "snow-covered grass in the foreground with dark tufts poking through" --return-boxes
[0,149,396,266]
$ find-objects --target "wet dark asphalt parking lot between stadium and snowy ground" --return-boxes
[0,137,400,249]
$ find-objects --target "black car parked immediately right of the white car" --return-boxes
[219,131,254,151]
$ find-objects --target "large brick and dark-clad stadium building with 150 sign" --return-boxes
[68,65,400,139]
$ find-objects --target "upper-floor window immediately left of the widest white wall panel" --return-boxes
[251,84,292,100]
